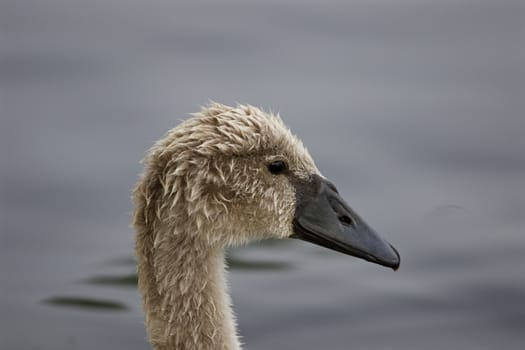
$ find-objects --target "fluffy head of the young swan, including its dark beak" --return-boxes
[134,103,399,269]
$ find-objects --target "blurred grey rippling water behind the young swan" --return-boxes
[0,0,525,350]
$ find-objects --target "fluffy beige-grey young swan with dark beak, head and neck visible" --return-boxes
[133,103,399,350]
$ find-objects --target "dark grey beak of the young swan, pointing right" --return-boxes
[292,176,400,270]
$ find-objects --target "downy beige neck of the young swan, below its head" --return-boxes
[137,236,240,350]
